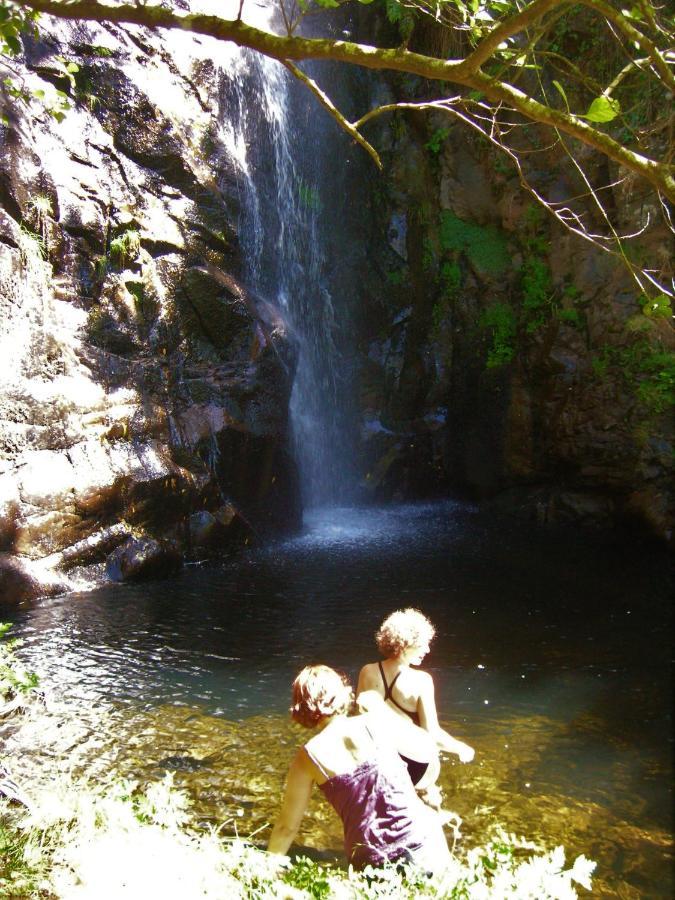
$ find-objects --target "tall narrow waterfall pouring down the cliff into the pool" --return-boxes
[222,0,357,507]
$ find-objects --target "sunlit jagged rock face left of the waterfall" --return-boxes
[0,17,299,600]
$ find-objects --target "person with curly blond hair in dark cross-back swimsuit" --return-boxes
[357,608,474,806]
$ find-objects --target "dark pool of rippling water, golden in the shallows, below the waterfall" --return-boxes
[7,504,673,898]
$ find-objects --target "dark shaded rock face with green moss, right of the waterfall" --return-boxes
[361,72,675,543]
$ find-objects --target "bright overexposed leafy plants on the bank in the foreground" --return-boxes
[0,776,595,900]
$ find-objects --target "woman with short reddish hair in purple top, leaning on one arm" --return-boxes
[267,665,450,872]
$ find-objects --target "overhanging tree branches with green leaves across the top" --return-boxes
[0,0,675,297]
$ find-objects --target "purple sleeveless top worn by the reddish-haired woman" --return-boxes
[305,732,440,869]
